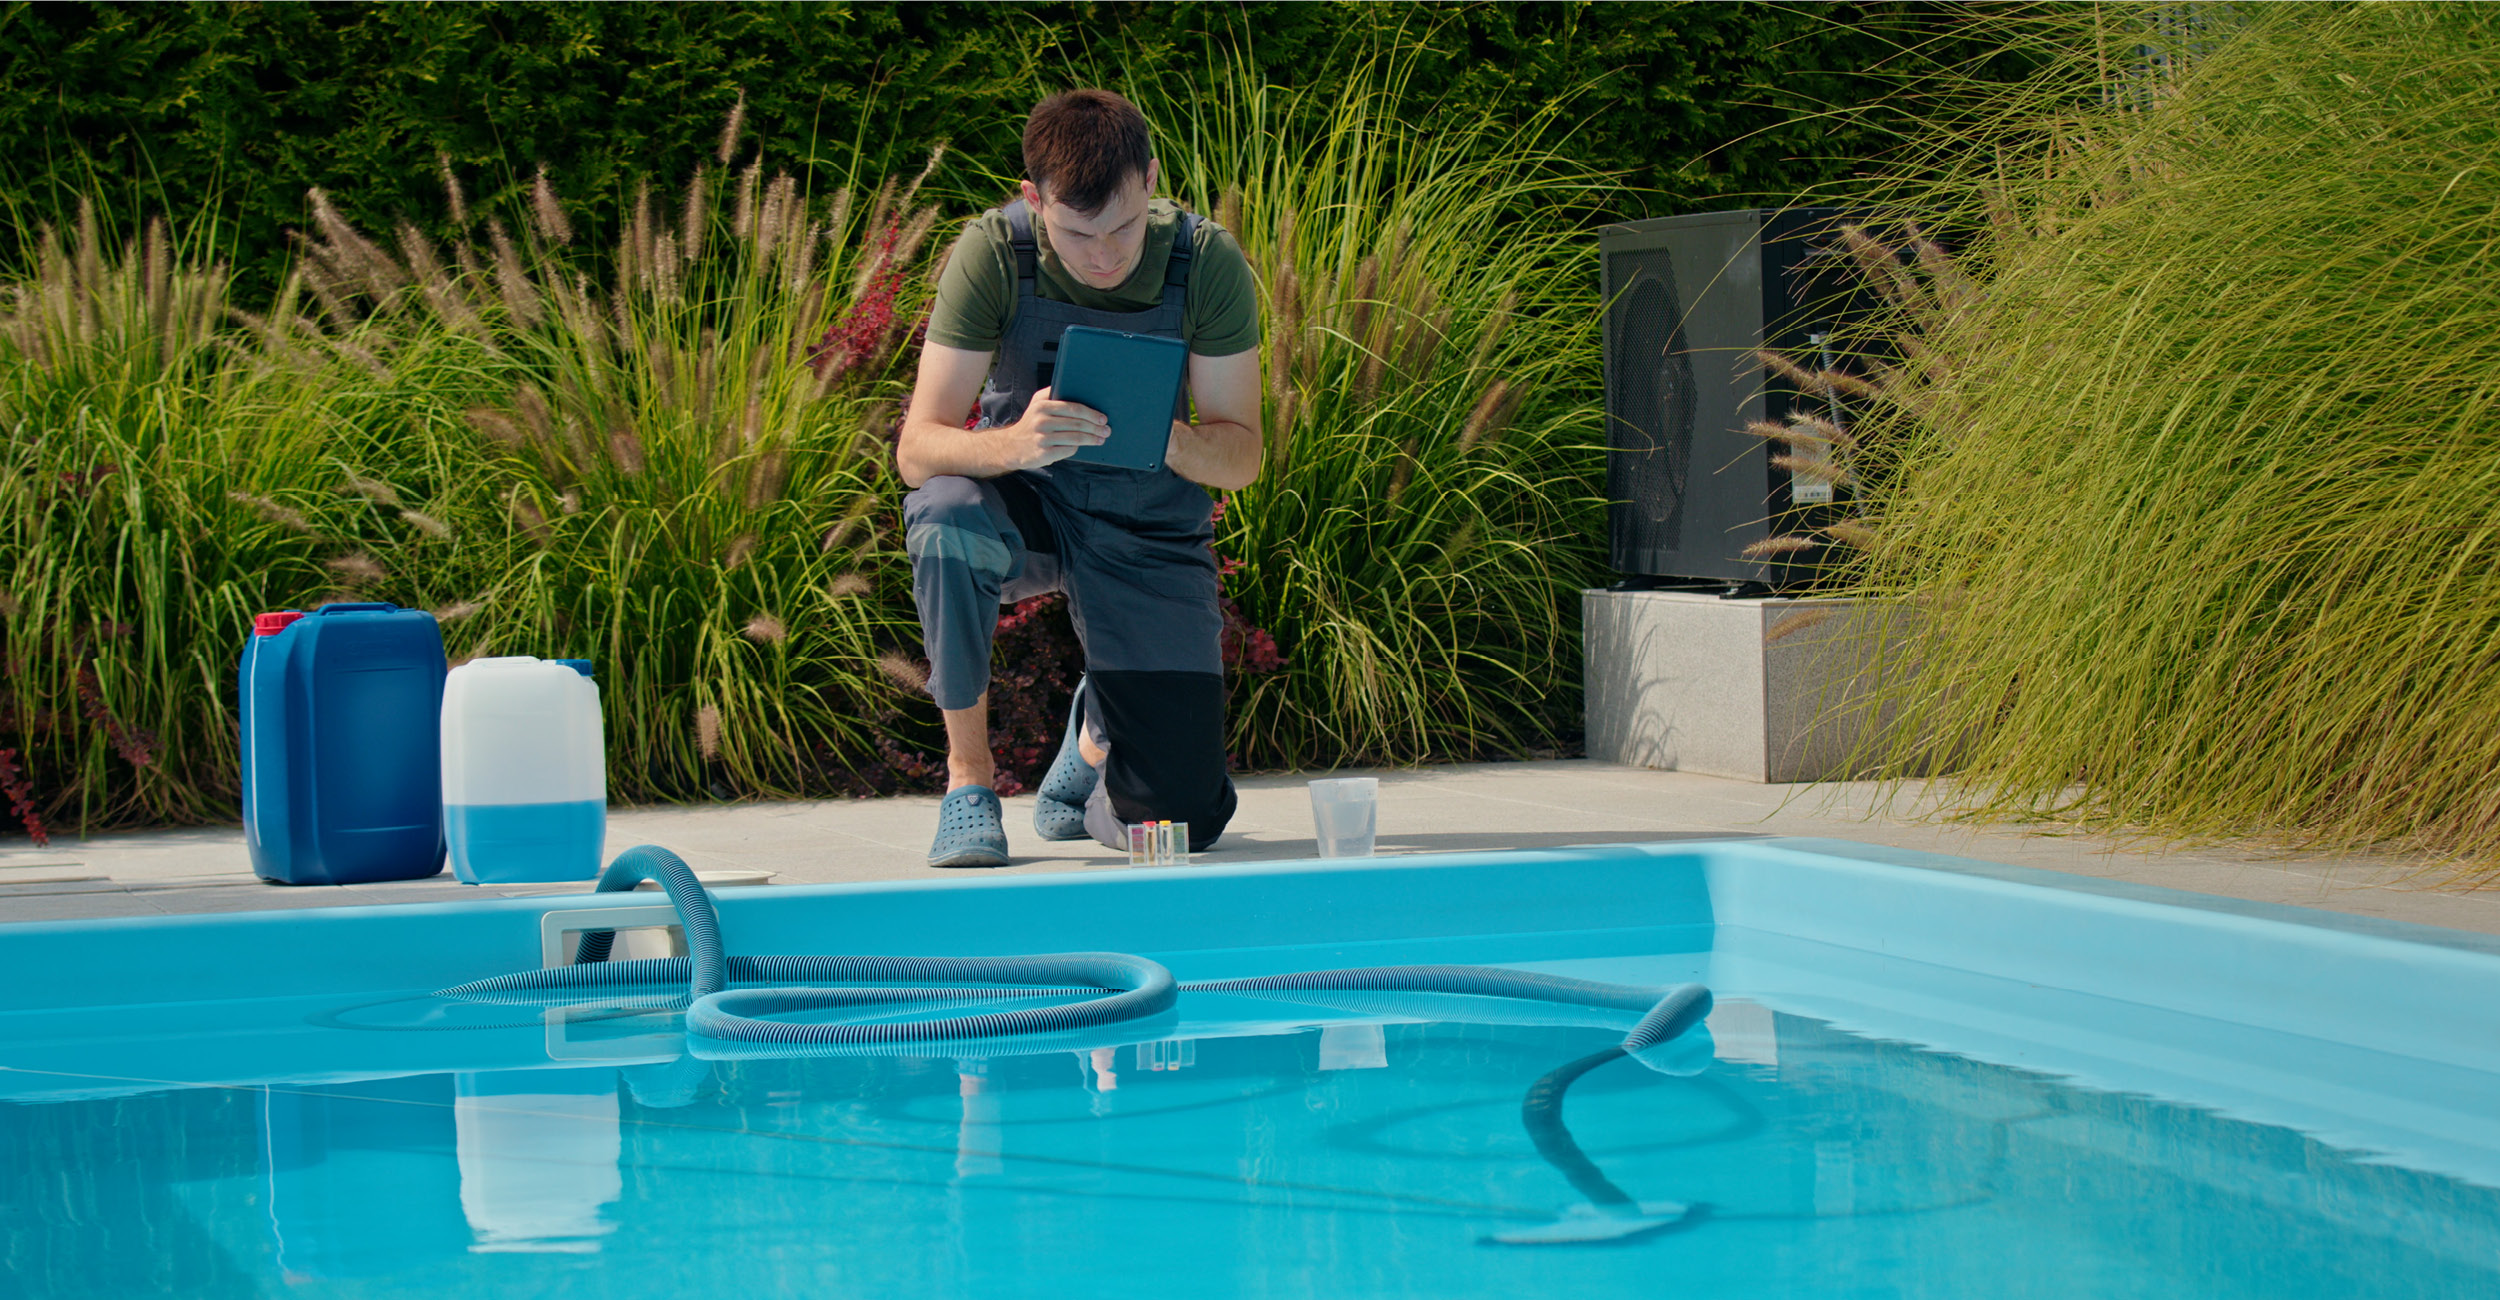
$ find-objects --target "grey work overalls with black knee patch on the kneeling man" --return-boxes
[903,200,1235,850]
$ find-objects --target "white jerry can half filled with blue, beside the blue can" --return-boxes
[443,655,608,885]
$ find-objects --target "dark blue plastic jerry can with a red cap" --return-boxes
[238,603,445,885]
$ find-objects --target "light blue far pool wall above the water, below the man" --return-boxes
[0,845,1715,1013]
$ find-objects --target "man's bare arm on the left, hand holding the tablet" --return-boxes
[895,343,1105,488]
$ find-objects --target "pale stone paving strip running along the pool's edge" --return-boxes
[0,760,2500,935]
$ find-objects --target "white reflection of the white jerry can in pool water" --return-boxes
[453,1070,625,1255]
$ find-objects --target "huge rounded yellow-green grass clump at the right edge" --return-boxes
[1853,5,2500,870]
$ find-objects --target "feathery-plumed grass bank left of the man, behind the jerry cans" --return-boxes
[0,126,935,835]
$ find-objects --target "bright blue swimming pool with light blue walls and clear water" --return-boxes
[0,840,2500,1300]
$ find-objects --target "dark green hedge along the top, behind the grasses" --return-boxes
[0,3,2010,298]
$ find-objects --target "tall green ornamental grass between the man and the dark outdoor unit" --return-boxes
[1128,58,1618,768]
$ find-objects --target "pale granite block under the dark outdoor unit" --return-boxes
[1580,590,1923,783]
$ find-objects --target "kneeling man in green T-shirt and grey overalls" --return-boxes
[895,90,1263,868]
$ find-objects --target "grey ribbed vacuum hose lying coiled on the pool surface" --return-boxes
[440,845,1710,1055]
